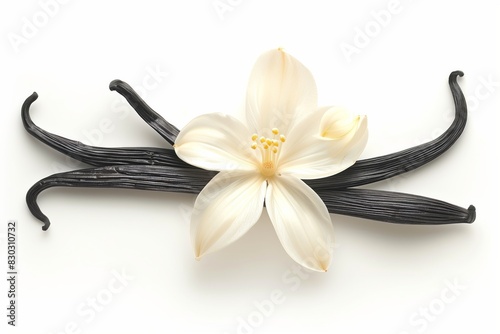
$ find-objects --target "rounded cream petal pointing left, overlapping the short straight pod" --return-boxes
[174,113,259,171]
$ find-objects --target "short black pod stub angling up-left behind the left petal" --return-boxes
[109,80,179,145]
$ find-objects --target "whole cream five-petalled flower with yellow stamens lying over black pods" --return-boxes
[174,49,367,271]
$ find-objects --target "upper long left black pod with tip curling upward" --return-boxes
[21,92,189,169]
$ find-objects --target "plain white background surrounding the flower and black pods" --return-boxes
[0,0,500,334]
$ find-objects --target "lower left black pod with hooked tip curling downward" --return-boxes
[26,165,217,231]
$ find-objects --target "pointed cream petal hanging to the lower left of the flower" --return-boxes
[191,171,266,258]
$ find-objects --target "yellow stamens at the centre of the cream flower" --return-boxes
[250,128,286,177]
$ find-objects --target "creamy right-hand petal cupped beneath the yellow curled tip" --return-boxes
[278,107,368,180]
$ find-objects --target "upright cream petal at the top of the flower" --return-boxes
[246,49,317,136]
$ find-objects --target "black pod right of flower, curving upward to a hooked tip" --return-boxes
[306,71,467,190]
